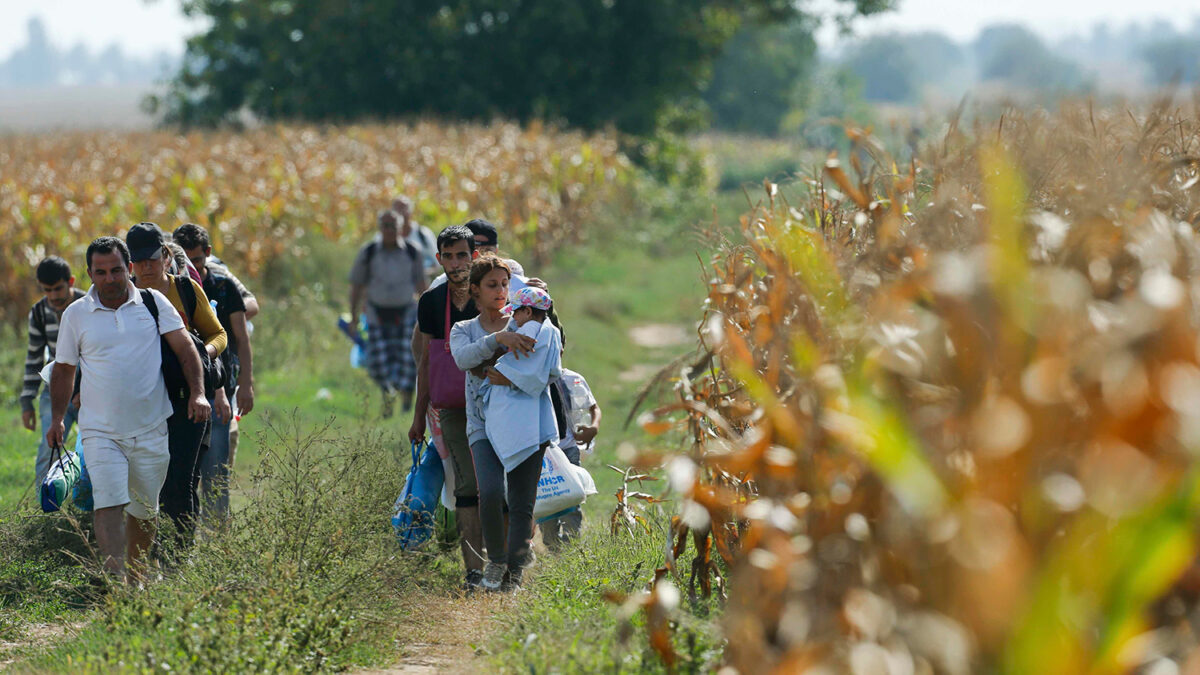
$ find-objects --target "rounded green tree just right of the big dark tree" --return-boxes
[704,17,816,135]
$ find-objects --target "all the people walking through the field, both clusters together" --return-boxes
[20,197,600,591]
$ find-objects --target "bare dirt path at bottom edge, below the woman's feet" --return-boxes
[361,591,516,675]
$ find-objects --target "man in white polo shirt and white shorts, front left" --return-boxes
[46,237,209,581]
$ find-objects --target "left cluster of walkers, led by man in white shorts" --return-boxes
[20,222,258,579]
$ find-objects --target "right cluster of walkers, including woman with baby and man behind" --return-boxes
[350,199,600,591]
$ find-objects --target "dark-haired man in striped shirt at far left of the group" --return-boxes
[20,256,84,485]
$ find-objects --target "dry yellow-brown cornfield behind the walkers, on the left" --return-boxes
[0,123,629,318]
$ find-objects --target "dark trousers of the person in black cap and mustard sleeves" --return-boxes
[158,408,209,546]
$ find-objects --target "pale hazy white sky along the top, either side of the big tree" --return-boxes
[0,0,1200,59]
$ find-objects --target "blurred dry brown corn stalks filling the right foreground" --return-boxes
[630,106,1200,674]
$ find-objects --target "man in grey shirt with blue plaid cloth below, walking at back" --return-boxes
[350,209,426,418]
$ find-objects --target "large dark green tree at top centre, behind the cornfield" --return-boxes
[162,0,889,133]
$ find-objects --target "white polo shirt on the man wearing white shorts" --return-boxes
[55,283,184,438]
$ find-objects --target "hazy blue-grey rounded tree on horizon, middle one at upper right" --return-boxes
[974,24,1085,91]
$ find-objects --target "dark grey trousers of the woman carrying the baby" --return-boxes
[470,438,546,569]
